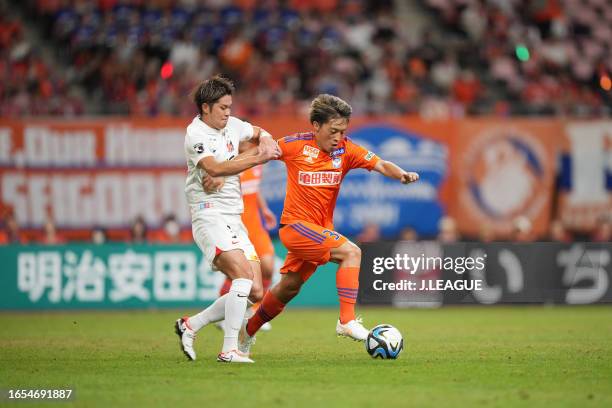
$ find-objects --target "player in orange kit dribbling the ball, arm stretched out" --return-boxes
[239,95,419,353]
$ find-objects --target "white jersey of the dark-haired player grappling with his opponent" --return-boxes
[185,116,253,218]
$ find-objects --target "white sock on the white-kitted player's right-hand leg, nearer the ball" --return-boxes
[222,278,253,353]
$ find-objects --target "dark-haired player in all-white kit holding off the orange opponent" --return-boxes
[175,76,280,363]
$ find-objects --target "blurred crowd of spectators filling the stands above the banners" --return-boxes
[0,0,612,117]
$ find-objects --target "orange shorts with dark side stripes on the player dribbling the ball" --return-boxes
[278,221,348,282]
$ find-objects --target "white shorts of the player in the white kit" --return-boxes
[192,213,259,270]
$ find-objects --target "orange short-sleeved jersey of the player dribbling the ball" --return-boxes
[278,133,380,229]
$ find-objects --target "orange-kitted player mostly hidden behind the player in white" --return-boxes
[215,165,276,330]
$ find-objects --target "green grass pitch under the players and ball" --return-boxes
[0,306,612,408]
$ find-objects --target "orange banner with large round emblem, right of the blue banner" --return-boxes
[449,119,561,238]
